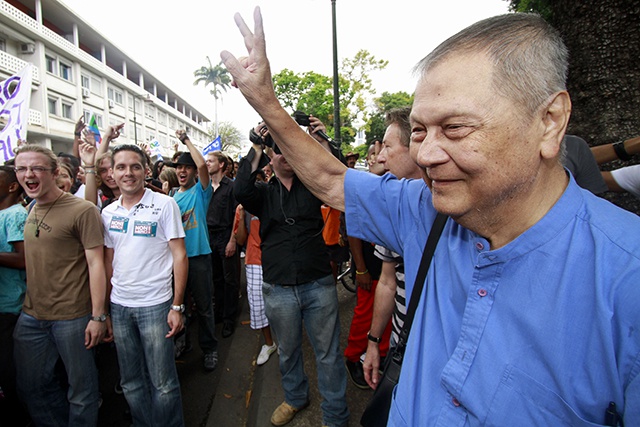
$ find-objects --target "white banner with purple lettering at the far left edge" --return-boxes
[0,64,33,162]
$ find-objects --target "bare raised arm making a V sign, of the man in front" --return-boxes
[220,7,347,210]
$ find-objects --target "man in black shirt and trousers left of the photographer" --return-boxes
[205,151,240,338]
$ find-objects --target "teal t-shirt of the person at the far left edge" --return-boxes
[0,204,28,314]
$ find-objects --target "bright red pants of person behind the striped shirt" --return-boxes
[344,280,391,362]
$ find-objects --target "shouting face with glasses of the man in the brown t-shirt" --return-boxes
[15,152,59,200]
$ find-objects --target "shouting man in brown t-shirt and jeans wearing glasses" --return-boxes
[14,145,107,426]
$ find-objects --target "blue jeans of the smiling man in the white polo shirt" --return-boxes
[111,300,184,427]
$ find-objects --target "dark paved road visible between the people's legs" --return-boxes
[98,266,372,427]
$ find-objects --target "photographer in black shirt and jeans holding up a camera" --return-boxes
[234,117,349,426]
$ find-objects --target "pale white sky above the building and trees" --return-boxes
[60,0,508,150]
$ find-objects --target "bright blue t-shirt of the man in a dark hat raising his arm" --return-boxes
[173,182,213,257]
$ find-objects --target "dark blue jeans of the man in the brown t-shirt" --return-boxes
[13,313,99,427]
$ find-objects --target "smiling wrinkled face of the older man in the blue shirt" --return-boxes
[410,53,542,218]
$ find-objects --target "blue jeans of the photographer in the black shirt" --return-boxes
[262,275,349,427]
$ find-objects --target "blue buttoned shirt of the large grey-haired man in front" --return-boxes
[345,169,640,427]
